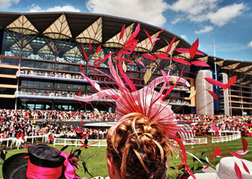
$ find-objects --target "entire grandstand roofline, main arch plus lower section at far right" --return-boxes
[0,12,252,83]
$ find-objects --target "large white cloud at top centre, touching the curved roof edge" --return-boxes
[86,0,168,26]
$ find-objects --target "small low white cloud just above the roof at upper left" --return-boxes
[30,4,80,12]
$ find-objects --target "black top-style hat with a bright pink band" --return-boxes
[2,144,76,179]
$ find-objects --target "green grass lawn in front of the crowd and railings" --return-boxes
[0,137,252,178]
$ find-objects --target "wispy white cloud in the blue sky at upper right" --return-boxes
[168,0,247,26]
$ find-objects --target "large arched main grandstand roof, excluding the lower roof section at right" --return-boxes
[0,12,193,50]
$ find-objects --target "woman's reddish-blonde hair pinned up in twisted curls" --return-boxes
[107,113,172,179]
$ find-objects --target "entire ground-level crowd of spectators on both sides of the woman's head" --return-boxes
[0,109,252,142]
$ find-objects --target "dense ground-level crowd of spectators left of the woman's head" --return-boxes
[0,109,115,139]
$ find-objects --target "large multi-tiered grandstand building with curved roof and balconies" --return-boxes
[0,12,252,115]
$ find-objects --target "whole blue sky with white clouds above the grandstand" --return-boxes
[0,0,252,61]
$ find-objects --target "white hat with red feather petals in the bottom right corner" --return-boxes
[189,157,252,179]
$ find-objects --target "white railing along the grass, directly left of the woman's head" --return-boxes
[53,138,107,147]
